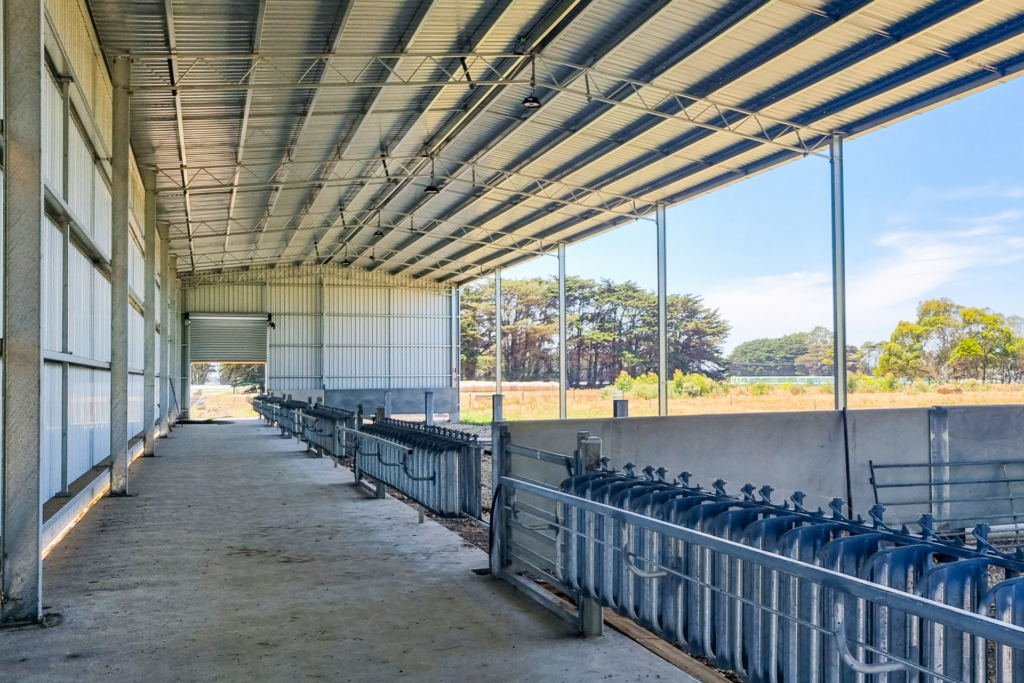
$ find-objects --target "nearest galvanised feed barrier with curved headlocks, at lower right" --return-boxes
[492,424,1024,683]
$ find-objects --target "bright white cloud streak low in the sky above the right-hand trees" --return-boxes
[705,225,1024,349]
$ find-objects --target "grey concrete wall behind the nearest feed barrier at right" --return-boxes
[501,405,1024,523]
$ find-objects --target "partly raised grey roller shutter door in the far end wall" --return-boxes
[188,313,266,362]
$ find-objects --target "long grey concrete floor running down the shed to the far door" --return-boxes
[0,421,693,683]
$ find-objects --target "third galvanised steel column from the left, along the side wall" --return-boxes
[142,170,157,456]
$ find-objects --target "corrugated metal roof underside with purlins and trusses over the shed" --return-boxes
[89,0,1024,283]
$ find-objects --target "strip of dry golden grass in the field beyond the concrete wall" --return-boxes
[462,385,1024,423]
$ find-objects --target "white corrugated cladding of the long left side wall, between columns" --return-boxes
[9,0,166,518]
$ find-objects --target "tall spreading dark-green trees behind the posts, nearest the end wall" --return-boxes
[462,278,729,387]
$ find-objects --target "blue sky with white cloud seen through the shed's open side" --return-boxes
[505,79,1024,350]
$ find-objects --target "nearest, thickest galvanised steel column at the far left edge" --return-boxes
[0,0,45,626]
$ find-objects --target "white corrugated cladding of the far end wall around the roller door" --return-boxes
[185,267,453,390]
